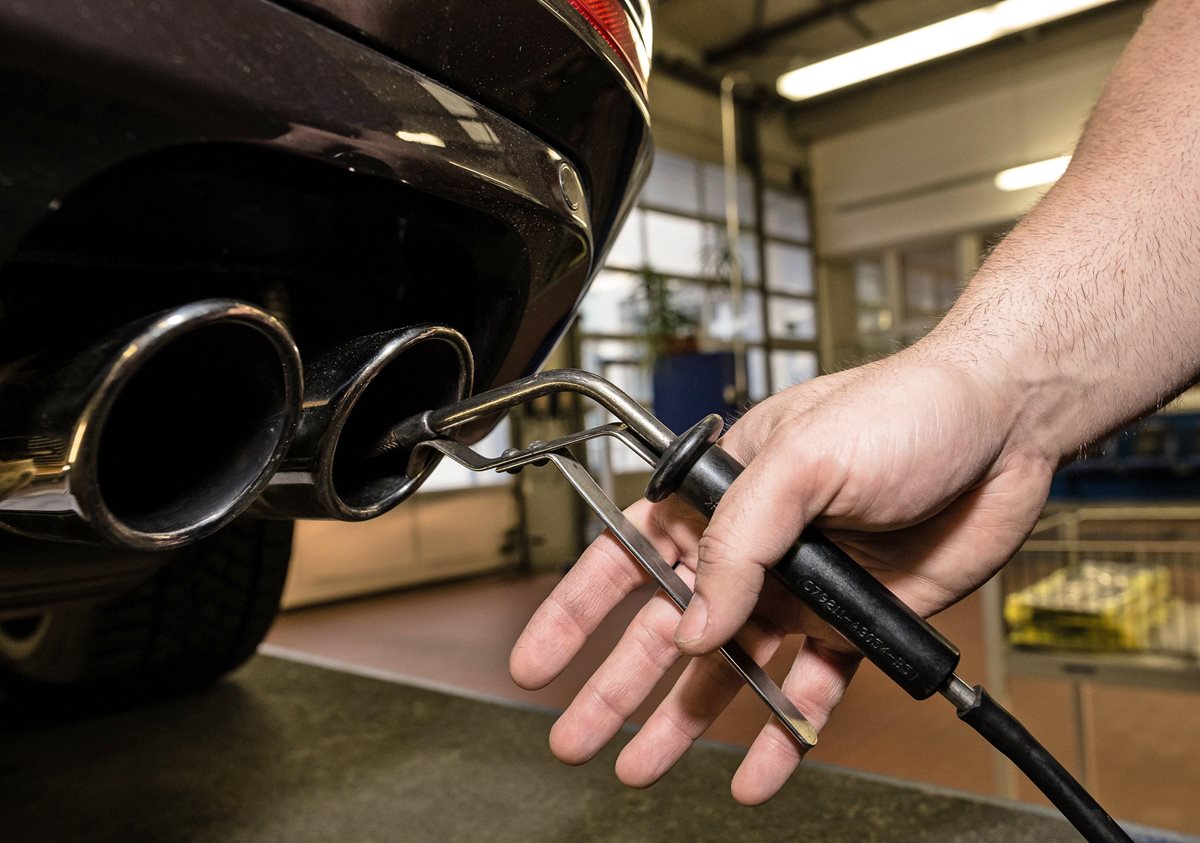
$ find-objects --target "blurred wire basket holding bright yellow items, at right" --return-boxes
[1002,507,1200,664]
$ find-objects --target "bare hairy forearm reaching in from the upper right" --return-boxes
[920,0,1200,459]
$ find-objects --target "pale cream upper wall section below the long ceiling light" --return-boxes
[810,35,1128,257]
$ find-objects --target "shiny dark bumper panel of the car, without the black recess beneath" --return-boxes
[0,0,628,398]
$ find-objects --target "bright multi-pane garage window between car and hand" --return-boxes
[580,151,818,482]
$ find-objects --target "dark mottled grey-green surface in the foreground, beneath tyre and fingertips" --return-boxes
[0,656,1186,843]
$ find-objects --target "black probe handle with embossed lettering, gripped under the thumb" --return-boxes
[676,447,959,700]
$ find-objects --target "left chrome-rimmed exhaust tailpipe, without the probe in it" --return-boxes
[0,299,301,550]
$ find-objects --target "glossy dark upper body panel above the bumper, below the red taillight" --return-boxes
[281,0,650,252]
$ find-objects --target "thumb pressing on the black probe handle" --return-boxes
[674,424,841,656]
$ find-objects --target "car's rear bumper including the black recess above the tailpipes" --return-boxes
[0,0,644,425]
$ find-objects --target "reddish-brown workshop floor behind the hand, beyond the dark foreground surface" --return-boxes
[266,575,1200,833]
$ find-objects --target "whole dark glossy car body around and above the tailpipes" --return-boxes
[0,0,650,686]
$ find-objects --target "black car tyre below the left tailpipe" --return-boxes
[0,520,293,704]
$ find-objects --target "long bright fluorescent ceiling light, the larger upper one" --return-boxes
[776,0,1112,100]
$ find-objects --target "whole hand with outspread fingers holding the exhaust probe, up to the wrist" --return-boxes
[510,349,1056,805]
